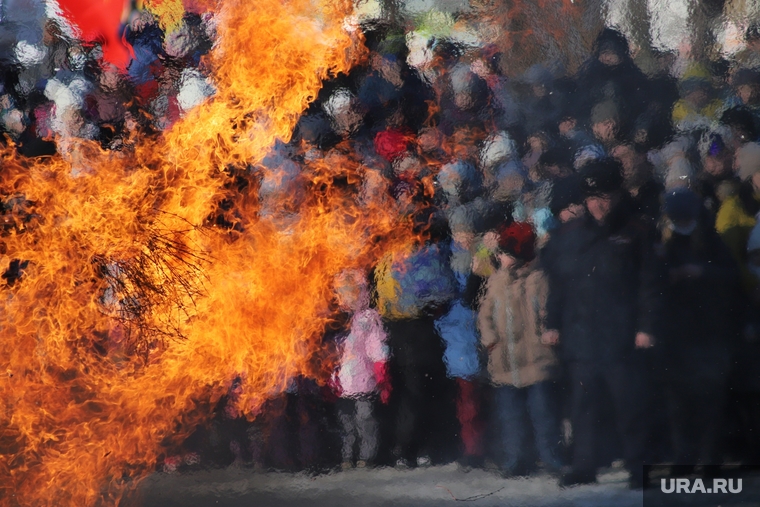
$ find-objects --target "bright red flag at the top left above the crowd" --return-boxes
[58,0,130,69]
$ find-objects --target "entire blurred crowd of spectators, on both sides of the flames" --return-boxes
[7,5,760,488]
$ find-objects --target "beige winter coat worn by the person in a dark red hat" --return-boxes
[478,262,557,387]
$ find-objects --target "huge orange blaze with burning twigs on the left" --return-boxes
[0,0,399,506]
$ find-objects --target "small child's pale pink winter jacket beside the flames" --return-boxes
[336,309,388,397]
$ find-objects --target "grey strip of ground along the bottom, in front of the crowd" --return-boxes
[137,464,643,507]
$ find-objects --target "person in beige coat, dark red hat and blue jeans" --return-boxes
[478,222,561,476]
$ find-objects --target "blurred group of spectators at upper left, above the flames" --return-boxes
[0,10,215,162]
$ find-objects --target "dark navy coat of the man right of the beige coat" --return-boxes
[542,202,662,365]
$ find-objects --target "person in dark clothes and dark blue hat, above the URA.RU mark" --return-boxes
[661,188,739,474]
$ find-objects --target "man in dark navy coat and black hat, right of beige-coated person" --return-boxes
[543,159,661,487]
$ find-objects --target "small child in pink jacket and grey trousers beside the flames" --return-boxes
[333,271,389,469]
